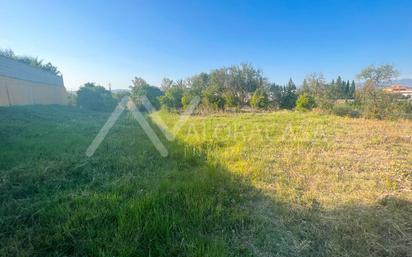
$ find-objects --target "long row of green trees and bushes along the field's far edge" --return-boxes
[78,64,412,118]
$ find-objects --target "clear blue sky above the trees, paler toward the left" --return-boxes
[0,0,412,90]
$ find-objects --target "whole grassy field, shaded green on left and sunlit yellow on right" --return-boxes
[0,106,412,257]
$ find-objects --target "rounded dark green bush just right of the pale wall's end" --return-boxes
[76,83,117,111]
